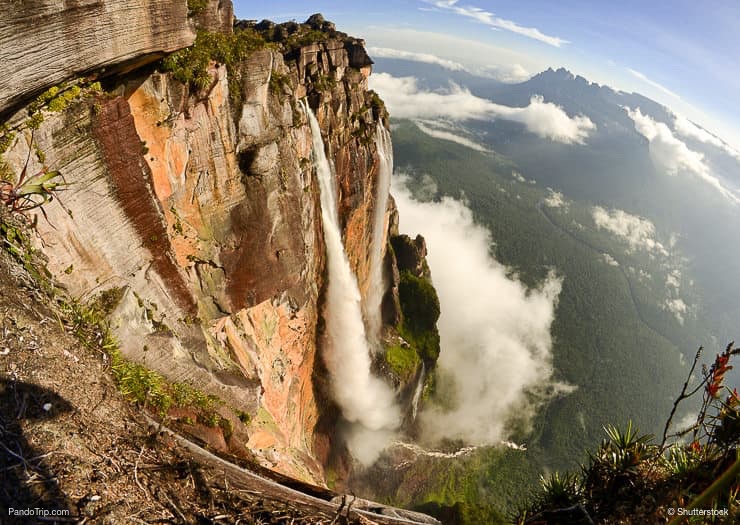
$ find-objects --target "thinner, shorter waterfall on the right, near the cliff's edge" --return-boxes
[365,122,393,348]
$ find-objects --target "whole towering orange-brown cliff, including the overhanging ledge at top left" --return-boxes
[0,0,428,484]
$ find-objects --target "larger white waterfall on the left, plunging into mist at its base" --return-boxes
[303,101,400,463]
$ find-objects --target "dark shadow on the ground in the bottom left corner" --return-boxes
[0,378,76,523]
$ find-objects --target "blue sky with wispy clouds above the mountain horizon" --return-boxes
[234,0,740,149]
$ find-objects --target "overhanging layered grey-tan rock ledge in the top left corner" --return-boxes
[0,0,197,115]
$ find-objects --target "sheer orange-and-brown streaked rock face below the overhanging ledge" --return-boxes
[0,14,392,483]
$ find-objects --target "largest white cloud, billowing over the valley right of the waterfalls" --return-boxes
[392,177,573,445]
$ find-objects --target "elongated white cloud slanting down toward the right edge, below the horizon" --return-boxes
[625,108,740,203]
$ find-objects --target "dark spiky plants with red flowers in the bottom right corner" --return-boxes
[518,343,740,524]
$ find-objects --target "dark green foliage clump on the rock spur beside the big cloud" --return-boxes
[398,270,440,362]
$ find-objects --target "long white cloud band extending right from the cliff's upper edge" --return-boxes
[370,73,596,144]
